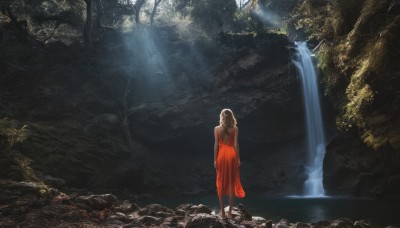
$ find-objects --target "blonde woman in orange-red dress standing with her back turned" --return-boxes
[214,109,245,219]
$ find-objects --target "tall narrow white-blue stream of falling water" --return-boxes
[294,42,325,197]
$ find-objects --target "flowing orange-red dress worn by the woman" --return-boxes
[216,128,245,198]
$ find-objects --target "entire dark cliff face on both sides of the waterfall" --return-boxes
[0,0,400,197]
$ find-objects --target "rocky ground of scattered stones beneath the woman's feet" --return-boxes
[0,180,380,228]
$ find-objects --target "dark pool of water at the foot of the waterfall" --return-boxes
[138,196,400,227]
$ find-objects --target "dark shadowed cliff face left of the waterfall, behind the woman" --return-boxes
[0,1,305,197]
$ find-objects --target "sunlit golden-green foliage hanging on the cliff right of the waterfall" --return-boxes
[308,0,400,149]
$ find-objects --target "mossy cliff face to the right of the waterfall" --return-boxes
[295,0,400,196]
